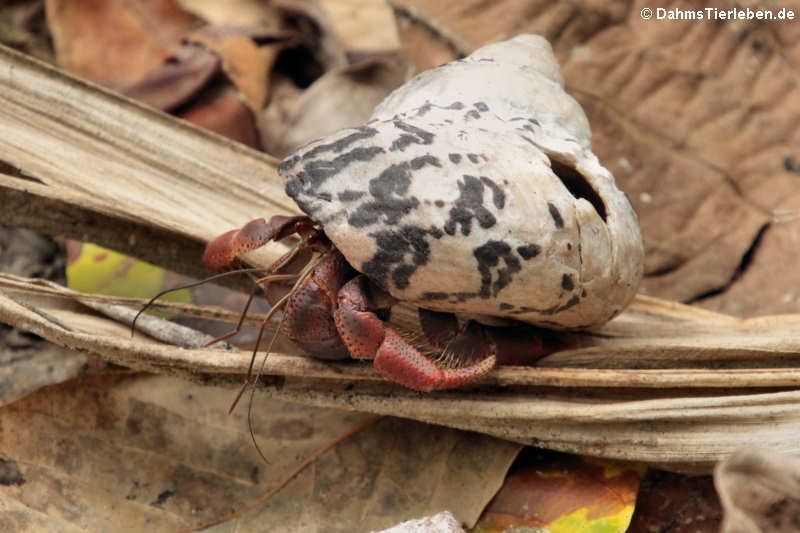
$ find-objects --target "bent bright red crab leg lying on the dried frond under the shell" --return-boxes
[334,276,495,392]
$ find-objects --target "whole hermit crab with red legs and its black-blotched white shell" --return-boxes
[204,35,643,391]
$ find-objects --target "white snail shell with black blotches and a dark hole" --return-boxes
[279,35,643,329]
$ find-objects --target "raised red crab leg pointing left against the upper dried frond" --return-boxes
[203,215,308,272]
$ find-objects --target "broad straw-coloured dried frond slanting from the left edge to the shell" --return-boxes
[0,43,296,278]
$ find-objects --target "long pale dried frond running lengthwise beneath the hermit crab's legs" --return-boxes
[0,277,800,471]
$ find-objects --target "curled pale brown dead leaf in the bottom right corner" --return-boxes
[714,448,800,533]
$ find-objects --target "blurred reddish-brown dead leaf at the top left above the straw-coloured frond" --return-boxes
[45,0,198,87]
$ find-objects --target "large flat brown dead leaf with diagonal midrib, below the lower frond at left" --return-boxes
[0,376,519,532]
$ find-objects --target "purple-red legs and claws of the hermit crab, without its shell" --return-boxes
[203,216,565,391]
